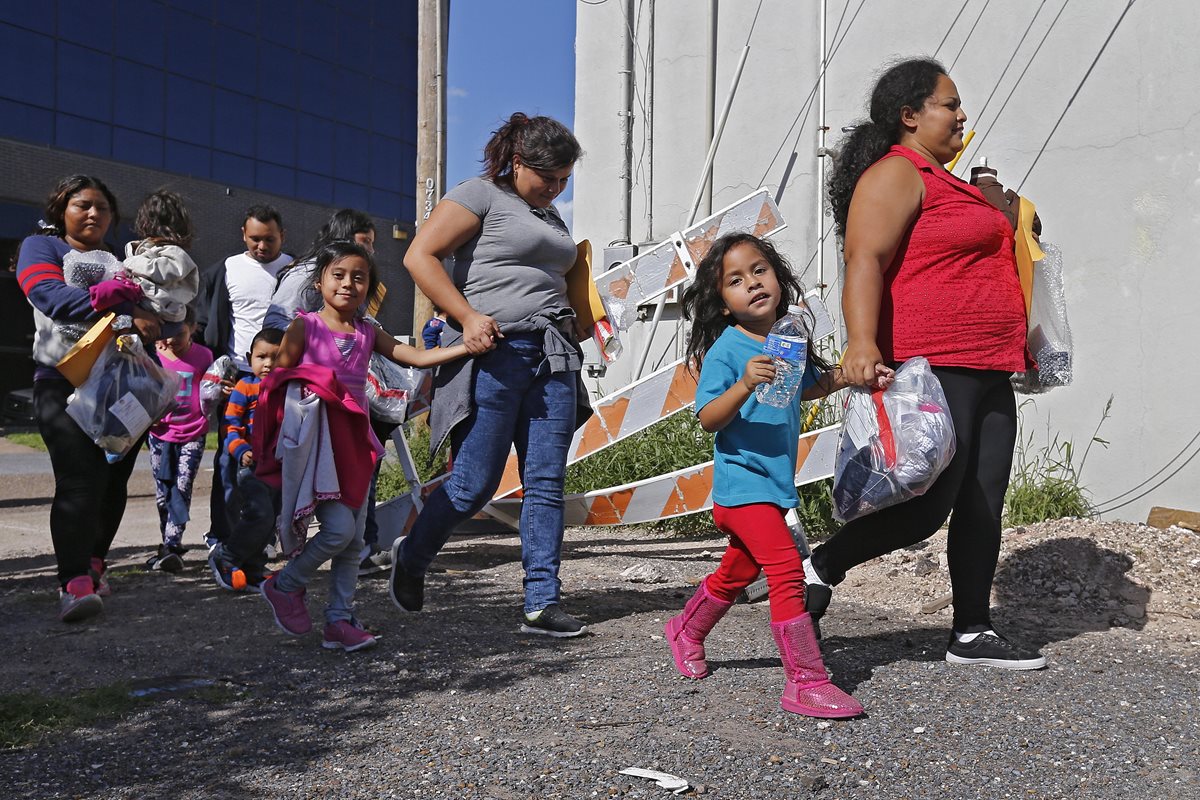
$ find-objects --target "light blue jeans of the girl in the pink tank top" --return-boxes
[275,500,367,622]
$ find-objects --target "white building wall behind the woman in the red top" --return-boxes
[575,0,1200,519]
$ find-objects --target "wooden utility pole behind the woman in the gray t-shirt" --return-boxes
[413,0,450,348]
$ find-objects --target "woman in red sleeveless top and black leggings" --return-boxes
[804,59,1045,669]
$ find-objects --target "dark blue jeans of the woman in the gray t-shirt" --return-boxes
[400,333,576,613]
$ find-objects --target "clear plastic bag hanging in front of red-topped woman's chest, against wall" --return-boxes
[1013,242,1075,395]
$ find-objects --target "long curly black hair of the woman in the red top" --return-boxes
[828,59,946,235]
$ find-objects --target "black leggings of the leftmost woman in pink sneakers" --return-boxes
[34,379,142,588]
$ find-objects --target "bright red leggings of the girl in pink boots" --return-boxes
[707,503,804,622]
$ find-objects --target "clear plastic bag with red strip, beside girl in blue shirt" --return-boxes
[833,357,955,522]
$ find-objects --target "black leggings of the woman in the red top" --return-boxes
[812,367,1016,633]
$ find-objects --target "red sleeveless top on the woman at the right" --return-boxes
[876,145,1026,372]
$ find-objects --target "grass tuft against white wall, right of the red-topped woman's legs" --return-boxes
[1004,397,1112,528]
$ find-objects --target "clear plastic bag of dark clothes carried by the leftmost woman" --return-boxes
[67,335,182,463]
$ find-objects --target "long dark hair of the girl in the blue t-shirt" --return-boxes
[682,234,829,374]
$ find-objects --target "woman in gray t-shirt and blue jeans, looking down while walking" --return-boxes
[391,113,586,637]
